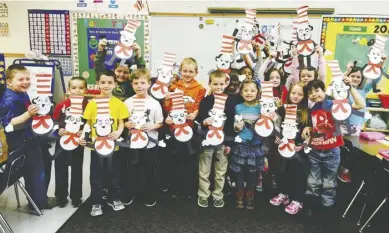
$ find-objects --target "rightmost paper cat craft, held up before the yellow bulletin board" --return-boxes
[362,34,389,93]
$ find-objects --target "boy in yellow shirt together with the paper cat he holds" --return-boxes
[80,71,129,216]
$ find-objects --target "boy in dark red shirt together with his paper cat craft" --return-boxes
[53,77,88,208]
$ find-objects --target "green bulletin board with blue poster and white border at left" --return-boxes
[72,12,150,86]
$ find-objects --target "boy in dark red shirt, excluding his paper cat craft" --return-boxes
[53,77,88,208]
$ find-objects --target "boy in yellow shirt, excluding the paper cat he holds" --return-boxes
[80,71,128,216]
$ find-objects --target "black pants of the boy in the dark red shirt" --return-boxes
[55,143,84,200]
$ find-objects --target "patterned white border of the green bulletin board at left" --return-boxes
[71,12,151,85]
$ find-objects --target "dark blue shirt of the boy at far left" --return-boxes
[0,88,33,150]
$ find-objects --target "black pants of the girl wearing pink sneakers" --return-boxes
[276,155,308,202]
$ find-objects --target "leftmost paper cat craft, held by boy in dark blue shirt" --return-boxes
[31,74,54,135]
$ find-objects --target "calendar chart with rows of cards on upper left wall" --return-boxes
[28,10,71,55]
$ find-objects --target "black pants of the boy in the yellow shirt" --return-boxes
[90,150,121,205]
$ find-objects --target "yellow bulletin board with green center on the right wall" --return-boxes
[320,16,389,98]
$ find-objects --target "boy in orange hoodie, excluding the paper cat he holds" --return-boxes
[165,58,206,198]
